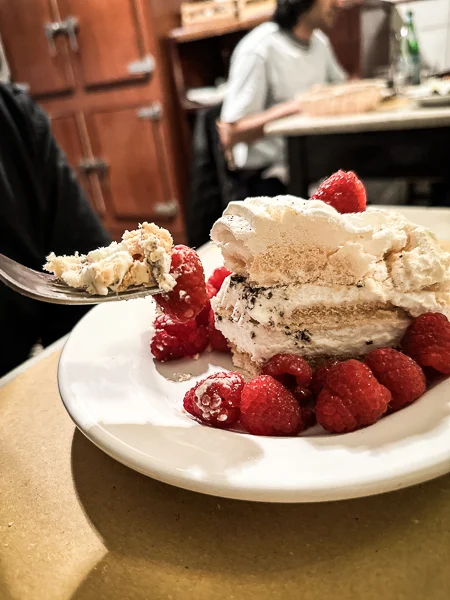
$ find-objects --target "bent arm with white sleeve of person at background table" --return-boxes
[218,54,299,148]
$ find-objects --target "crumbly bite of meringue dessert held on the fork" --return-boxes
[44,223,176,296]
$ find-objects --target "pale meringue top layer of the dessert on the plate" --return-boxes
[211,196,450,293]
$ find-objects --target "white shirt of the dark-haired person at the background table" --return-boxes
[221,22,346,179]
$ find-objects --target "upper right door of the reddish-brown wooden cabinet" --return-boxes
[58,0,153,87]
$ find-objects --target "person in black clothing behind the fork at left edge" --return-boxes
[0,84,111,376]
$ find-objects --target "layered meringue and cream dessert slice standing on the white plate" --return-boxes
[211,196,450,373]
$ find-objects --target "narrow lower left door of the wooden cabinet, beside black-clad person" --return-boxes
[52,115,105,217]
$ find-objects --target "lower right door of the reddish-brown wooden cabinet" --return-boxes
[87,108,178,227]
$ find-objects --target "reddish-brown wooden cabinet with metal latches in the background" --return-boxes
[0,0,184,242]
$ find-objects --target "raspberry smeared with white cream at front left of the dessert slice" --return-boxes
[183,372,245,428]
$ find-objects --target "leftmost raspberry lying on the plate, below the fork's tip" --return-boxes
[150,315,208,362]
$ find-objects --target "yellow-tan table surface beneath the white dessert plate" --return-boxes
[0,353,450,600]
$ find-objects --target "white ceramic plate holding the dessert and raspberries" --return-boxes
[58,246,450,502]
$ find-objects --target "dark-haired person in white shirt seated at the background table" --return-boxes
[218,0,346,196]
